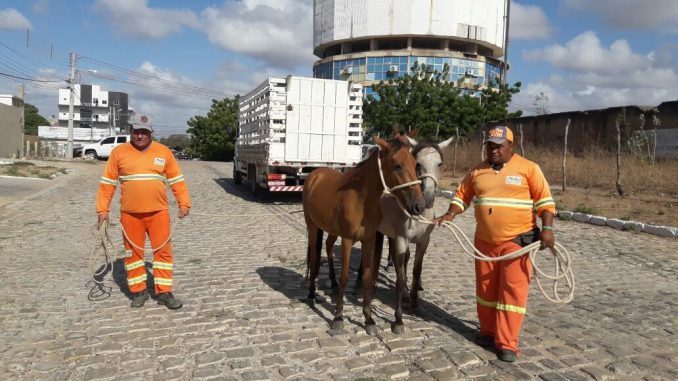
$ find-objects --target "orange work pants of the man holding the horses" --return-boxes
[475,238,532,353]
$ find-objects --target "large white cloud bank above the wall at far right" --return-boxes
[514,31,678,114]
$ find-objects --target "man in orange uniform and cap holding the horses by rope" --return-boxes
[437,126,556,362]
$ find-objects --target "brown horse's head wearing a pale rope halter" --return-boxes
[374,134,425,215]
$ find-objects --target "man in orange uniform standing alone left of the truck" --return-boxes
[97,124,191,309]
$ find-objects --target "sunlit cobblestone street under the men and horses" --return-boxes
[0,161,678,381]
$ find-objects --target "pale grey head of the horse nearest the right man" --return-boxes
[408,136,454,209]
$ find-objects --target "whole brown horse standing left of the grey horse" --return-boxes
[302,135,425,335]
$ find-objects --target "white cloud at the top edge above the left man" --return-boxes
[94,0,199,39]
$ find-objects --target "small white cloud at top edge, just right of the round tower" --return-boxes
[509,3,553,40]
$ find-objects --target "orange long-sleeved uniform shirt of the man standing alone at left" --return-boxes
[97,142,191,213]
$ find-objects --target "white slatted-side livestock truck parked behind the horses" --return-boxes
[233,76,363,195]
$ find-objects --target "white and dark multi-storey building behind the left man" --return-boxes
[58,84,131,132]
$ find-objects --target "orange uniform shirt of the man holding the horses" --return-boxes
[452,154,556,244]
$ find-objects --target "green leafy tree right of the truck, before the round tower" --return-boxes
[364,63,520,140]
